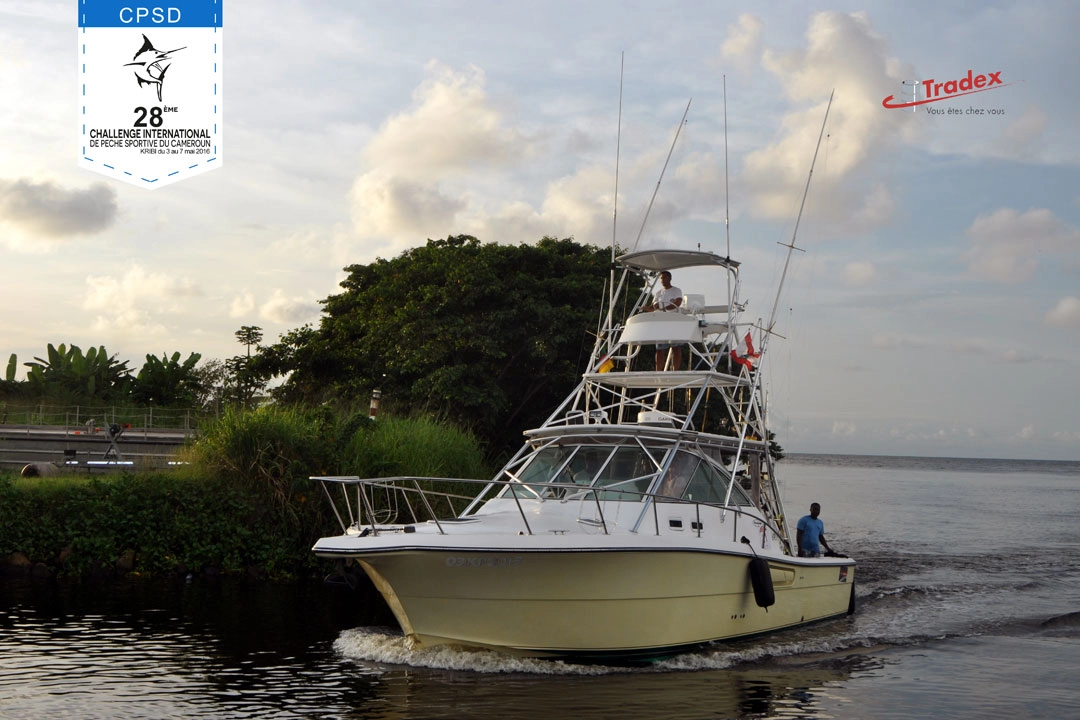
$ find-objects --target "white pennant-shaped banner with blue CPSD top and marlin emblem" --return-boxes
[78,0,222,188]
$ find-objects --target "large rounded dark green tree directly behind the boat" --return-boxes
[253,235,610,449]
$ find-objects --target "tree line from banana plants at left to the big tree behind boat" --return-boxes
[6,235,630,458]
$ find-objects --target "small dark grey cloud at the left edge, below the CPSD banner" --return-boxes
[0,178,117,252]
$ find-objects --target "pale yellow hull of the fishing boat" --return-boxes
[345,548,854,660]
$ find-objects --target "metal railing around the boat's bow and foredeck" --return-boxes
[311,476,784,546]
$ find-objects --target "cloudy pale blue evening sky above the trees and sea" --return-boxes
[0,0,1080,460]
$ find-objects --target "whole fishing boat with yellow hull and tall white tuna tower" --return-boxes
[313,95,855,662]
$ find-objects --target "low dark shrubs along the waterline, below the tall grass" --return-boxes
[0,473,315,576]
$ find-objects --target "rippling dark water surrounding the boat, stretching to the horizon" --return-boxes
[0,456,1080,720]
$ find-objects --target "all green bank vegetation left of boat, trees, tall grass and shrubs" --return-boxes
[0,235,617,578]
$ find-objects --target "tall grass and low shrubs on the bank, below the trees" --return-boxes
[0,406,488,578]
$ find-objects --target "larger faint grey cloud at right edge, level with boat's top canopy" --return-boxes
[963,207,1080,285]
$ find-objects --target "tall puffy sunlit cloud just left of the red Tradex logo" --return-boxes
[743,12,906,229]
